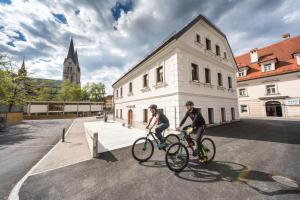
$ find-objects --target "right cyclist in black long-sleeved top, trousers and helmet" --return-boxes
[176,101,206,162]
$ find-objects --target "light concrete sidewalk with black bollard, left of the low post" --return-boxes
[32,117,96,174]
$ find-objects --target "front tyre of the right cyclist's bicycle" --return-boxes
[165,142,189,172]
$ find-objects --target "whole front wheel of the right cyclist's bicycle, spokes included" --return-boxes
[165,142,189,172]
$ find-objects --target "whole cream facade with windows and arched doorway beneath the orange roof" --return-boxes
[238,72,300,118]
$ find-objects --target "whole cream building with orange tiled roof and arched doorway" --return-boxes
[236,36,300,118]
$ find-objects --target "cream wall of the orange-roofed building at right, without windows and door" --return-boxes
[237,72,300,117]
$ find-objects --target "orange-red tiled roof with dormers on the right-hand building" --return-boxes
[235,36,300,81]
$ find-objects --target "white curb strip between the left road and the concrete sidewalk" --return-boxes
[8,119,76,200]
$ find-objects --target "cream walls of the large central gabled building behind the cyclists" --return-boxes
[114,18,239,129]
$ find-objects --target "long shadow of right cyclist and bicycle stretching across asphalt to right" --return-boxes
[175,160,300,196]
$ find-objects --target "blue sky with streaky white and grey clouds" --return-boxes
[0,0,300,94]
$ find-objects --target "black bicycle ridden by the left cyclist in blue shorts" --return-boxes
[131,129,180,162]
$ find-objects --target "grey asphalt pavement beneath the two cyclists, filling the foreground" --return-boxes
[20,120,300,200]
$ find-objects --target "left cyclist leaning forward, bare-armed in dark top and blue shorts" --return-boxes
[146,104,170,149]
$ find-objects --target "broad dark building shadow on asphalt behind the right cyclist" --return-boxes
[205,119,300,144]
